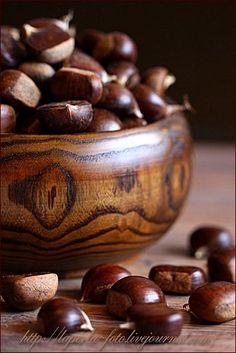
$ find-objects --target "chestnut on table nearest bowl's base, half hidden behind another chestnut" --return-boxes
[81,264,131,303]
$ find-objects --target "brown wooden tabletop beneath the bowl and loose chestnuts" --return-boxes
[1,144,235,352]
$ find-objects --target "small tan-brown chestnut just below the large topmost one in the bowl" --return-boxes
[18,61,55,87]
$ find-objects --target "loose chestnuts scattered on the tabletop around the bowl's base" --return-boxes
[1,227,235,342]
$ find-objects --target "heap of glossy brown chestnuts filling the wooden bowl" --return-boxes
[0,13,191,134]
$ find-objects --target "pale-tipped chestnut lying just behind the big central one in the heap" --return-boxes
[63,48,116,83]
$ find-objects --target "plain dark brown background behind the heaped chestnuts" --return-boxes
[2,0,236,141]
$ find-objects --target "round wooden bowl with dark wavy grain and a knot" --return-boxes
[1,114,191,273]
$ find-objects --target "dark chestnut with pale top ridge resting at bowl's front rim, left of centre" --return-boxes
[36,101,93,134]
